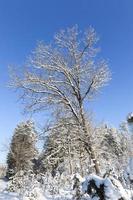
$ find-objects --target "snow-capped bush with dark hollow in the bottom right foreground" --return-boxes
[82,175,133,200]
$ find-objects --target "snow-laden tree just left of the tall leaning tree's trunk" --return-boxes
[40,117,85,175]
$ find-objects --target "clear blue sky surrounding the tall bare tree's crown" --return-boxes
[0,0,133,163]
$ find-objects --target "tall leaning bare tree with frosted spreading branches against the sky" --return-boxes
[12,26,110,174]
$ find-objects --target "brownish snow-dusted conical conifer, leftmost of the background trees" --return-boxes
[7,121,37,177]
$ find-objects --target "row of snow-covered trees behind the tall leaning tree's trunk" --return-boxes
[6,117,132,198]
